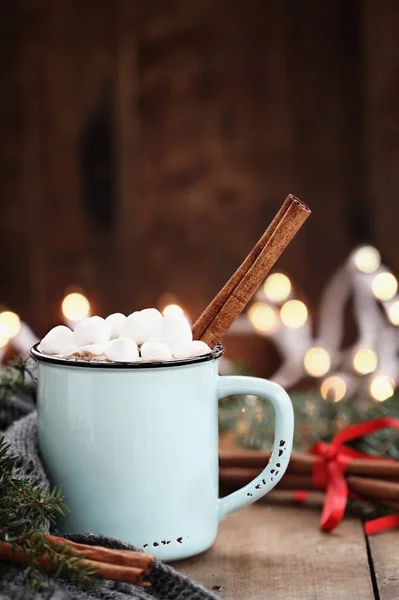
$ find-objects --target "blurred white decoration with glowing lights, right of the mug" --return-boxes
[230,246,399,402]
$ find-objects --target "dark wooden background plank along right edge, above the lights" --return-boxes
[363,0,399,272]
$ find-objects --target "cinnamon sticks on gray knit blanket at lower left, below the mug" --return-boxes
[0,535,153,586]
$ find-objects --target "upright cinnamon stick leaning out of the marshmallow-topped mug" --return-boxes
[193,194,310,348]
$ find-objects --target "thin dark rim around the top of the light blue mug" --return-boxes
[30,342,224,369]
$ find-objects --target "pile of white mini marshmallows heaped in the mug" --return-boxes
[38,308,211,362]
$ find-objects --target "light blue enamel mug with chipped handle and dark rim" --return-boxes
[31,346,294,560]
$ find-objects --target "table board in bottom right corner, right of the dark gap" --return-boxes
[368,529,399,600]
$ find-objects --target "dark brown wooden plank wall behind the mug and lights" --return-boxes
[0,0,399,333]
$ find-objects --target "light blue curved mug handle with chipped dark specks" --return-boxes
[217,375,294,521]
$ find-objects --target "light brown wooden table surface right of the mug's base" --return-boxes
[174,502,399,600]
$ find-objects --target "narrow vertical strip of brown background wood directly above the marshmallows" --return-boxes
[115,0,141,314]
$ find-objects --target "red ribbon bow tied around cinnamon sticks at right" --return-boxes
[306,417,399,533]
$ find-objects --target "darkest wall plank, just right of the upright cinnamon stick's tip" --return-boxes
[279,0,367,297]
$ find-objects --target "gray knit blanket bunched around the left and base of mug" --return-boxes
[0,366,216,600]
